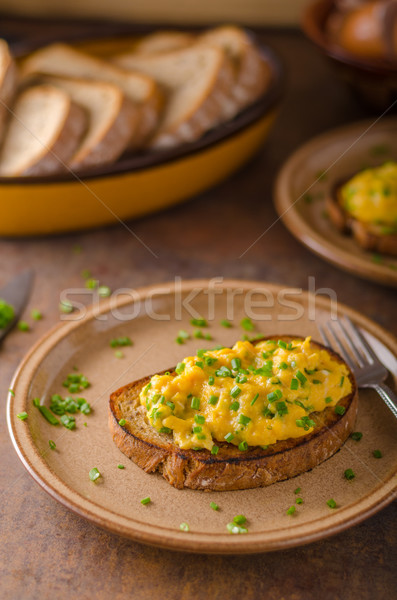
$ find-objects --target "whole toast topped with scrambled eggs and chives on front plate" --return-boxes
[109,336,358,491]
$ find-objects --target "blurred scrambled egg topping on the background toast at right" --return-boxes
[341,162,397,233]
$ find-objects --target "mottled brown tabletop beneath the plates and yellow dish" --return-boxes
[0,22,397,600]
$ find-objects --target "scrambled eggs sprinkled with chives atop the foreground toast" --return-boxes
[140,337,351,453]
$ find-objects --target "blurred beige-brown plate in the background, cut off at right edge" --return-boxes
[275,117,397,287]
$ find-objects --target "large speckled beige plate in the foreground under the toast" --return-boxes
[8,280,397,553]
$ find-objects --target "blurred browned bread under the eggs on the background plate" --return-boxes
[326,180,397,256]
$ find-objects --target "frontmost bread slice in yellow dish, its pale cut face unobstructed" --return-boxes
[0,85,87,177]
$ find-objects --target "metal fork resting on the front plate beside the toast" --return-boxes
[318,316,397,417]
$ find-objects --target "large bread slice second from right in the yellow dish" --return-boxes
[114,44,234,148]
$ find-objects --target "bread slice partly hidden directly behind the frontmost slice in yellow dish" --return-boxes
[41,76,139,170]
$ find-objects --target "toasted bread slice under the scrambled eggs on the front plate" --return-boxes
[109,336,358,491]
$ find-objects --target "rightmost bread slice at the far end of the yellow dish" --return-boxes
[199,25,271,110]
